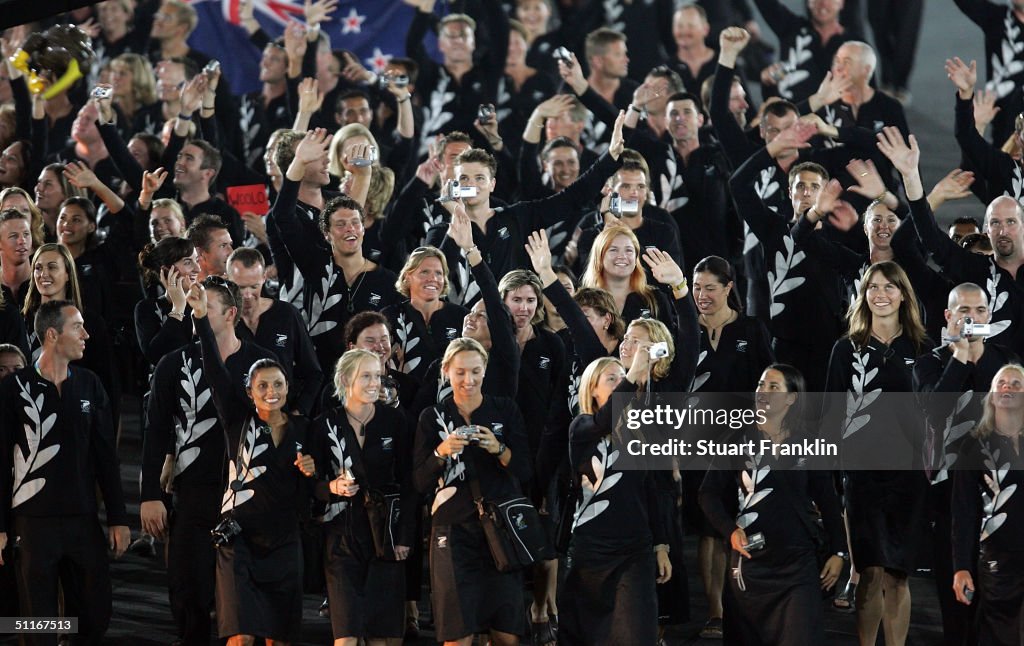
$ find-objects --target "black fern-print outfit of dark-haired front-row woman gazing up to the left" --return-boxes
[700,429,846,646]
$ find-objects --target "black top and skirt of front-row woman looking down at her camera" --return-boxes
[413,395,530,641]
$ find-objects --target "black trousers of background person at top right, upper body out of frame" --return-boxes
[867,0,925,90]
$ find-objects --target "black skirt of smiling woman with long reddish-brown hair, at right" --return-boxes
[846,471,928,574]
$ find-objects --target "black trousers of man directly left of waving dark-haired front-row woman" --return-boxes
[167,486,222,646]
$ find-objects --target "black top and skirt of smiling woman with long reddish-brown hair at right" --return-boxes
[824,336,930,574]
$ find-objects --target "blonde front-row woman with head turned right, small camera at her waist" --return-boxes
[312,349,418,646]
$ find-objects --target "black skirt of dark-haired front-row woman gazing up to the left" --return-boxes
[726,550,825,646]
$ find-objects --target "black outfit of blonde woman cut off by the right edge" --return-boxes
[952,432,1024,646]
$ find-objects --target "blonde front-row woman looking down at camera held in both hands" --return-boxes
[413,337,531,646]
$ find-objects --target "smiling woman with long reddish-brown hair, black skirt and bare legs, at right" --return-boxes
[825,261,932,644]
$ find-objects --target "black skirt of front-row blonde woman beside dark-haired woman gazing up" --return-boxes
[558,549,657,646]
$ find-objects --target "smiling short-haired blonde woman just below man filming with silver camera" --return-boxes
[382,247,469,380]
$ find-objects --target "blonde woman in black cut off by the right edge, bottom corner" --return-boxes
[952,363,1024,646]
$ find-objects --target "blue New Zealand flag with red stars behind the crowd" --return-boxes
[188,0,414,94]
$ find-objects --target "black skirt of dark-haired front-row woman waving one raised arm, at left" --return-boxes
[211,527,302,642]
